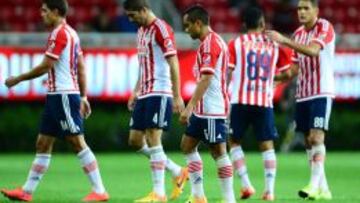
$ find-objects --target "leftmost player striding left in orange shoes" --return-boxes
[1,0,109,201]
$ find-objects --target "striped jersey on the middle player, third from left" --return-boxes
[194,31,229,118]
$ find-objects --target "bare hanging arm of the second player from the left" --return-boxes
[166,55,184,113]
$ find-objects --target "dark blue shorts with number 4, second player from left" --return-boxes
[130,96,172,131]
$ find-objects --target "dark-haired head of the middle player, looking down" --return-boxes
[183,5,210,39]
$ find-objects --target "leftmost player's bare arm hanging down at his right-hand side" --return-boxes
[78,54,91,118]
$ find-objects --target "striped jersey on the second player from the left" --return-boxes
[137,18,177,98]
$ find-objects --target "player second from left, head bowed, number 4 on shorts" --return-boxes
[124,0,188,202]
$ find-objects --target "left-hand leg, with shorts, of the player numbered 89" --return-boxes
[228,104,255,199]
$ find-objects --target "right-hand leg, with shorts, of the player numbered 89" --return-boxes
[252,107,278,201]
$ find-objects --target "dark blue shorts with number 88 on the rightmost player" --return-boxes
[295,97,333,134]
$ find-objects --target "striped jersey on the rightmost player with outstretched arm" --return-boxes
[293,19,335,101]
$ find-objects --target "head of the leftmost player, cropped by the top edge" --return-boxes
[41,0,68,26]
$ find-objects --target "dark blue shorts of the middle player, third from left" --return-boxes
[185,115,228,144]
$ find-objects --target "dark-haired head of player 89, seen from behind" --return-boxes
[243,7,265,31]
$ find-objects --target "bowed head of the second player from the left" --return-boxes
[123,0,150,26]
